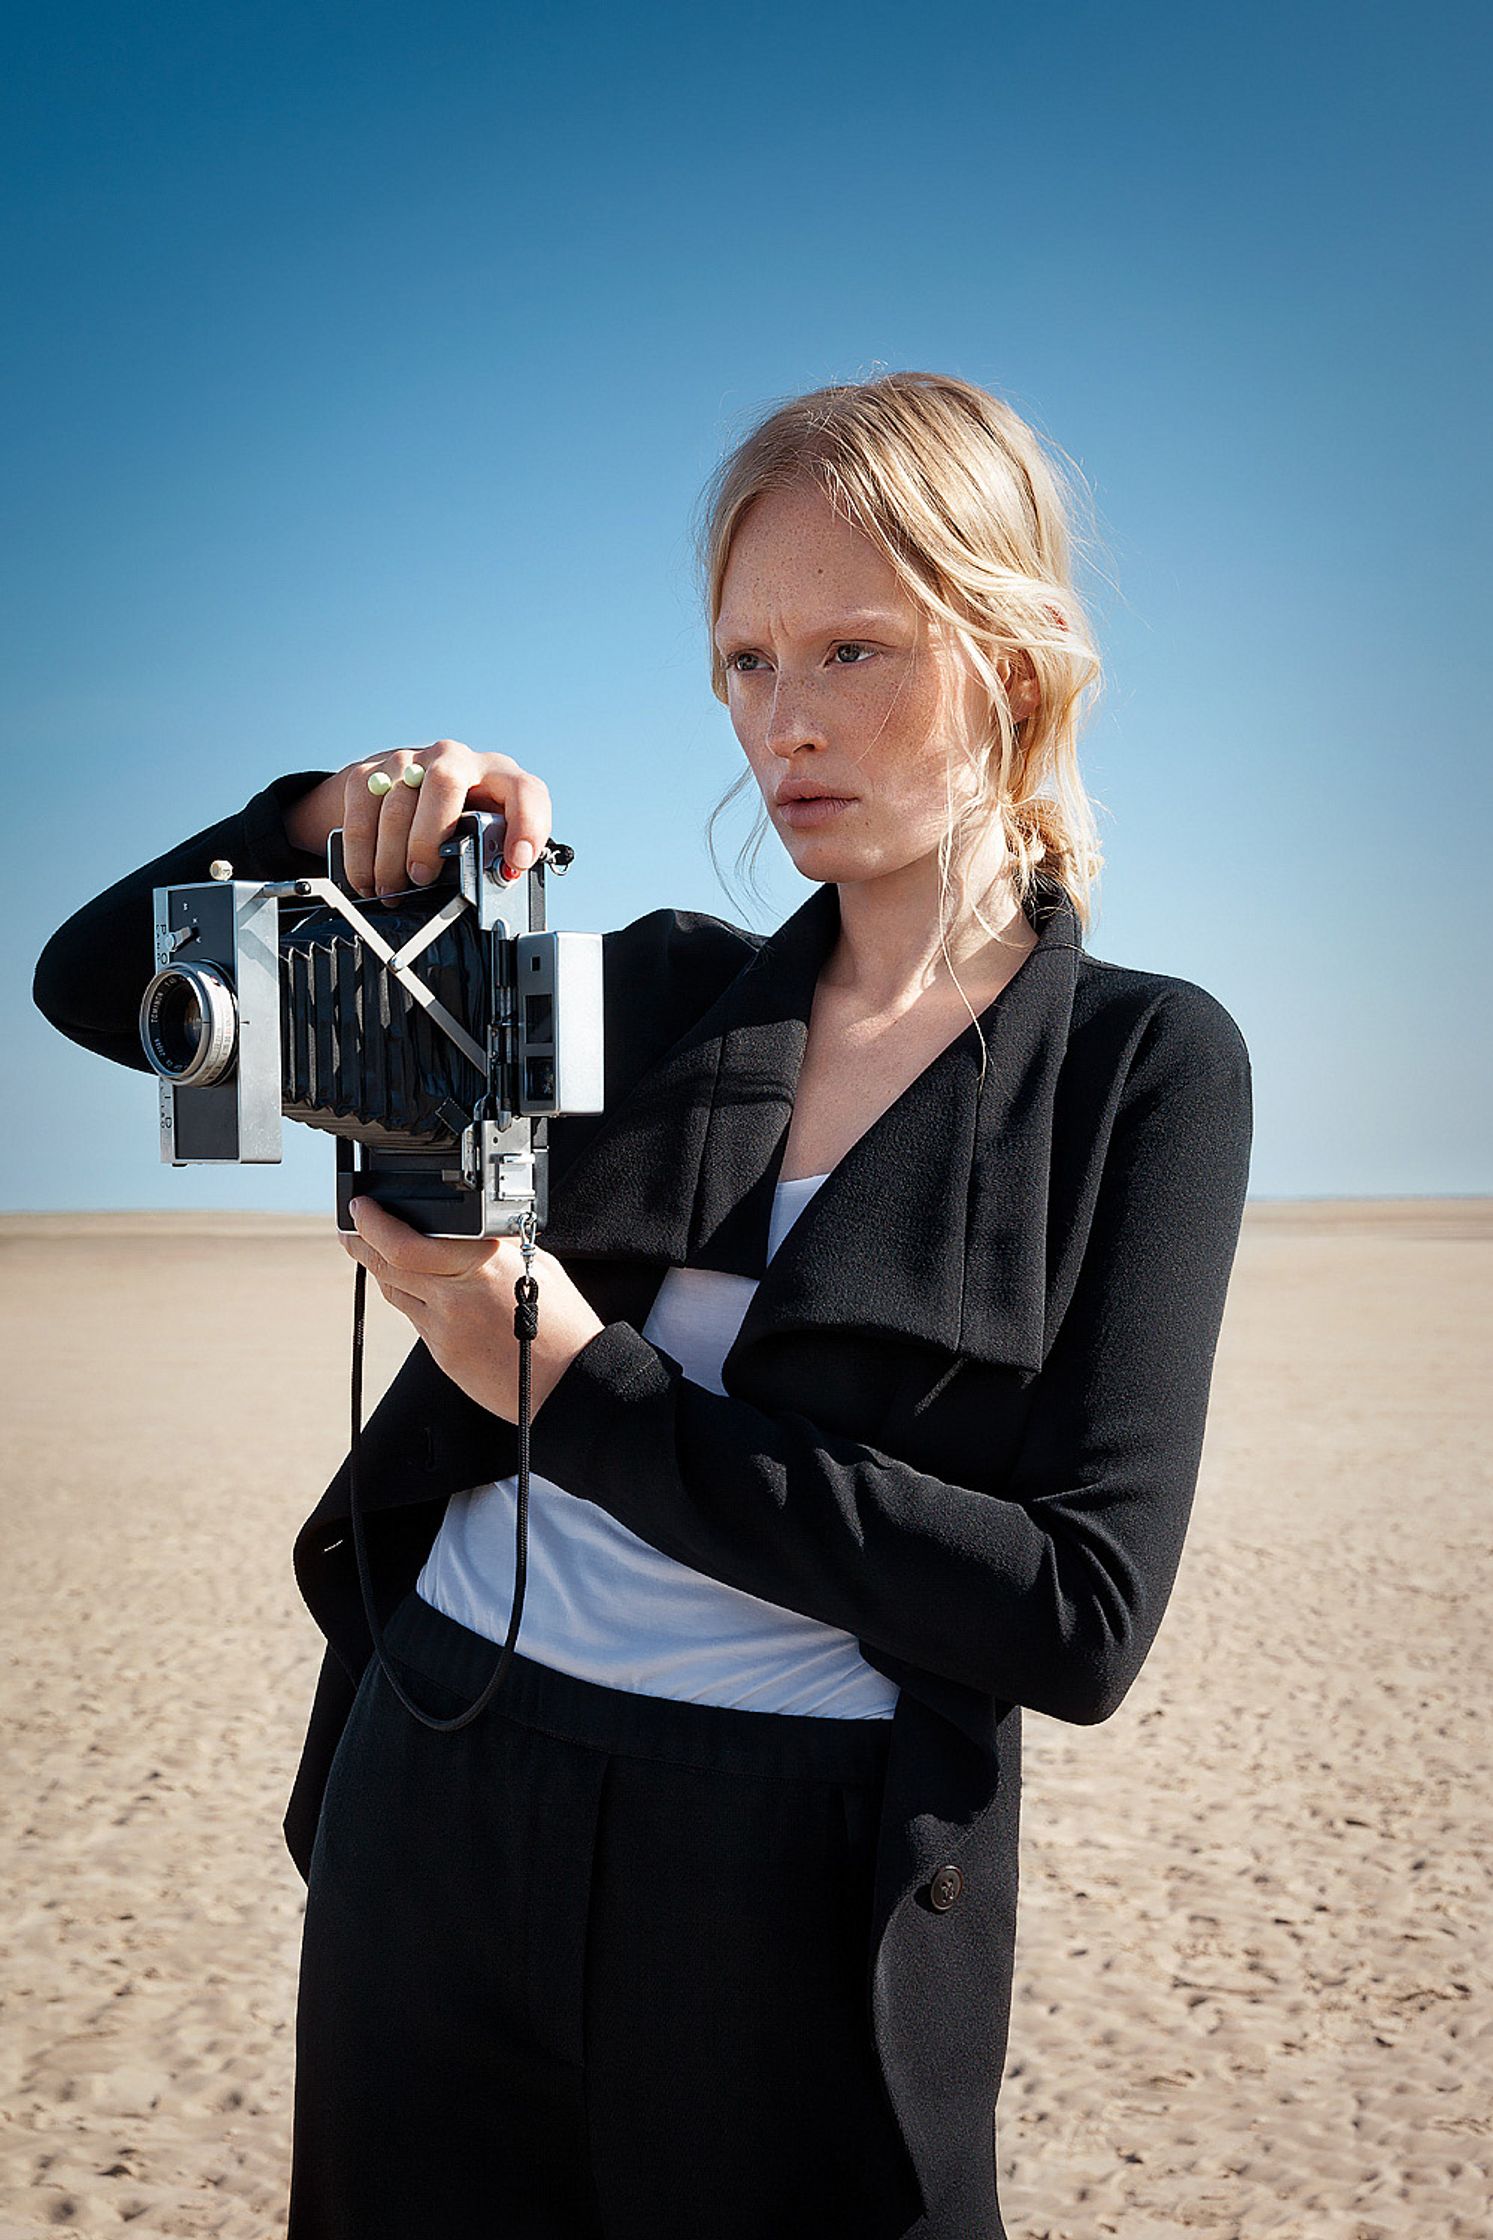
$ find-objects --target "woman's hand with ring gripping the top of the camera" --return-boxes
[284,739,551,896]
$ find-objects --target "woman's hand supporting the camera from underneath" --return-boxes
[342,1198,604,1422]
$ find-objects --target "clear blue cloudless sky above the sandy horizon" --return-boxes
[0,0,1493,1210]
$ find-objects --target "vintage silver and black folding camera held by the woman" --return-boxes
[141,809,602,1236]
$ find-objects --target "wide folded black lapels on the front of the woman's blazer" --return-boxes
[544,876,1081,1389]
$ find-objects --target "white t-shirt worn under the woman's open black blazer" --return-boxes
[416,1174,898,1718]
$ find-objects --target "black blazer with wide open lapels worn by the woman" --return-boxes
[36,771,1251,2211]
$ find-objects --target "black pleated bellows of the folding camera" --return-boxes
[280,909,490,1149]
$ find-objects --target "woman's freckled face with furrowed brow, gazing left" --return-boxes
[716,484,1011,880]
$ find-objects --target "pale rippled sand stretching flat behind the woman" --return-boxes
[0,1198,1493,2240]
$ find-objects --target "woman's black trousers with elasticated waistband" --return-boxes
[289,1595,940,2240]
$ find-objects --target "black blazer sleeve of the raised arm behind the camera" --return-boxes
[31,771,331,1073]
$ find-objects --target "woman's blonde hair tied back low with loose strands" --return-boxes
[696,374,1104,936]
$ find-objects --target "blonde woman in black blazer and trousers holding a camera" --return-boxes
[36,374,1251,2240]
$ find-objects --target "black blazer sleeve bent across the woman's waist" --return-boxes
[533,981,1251,1725]
